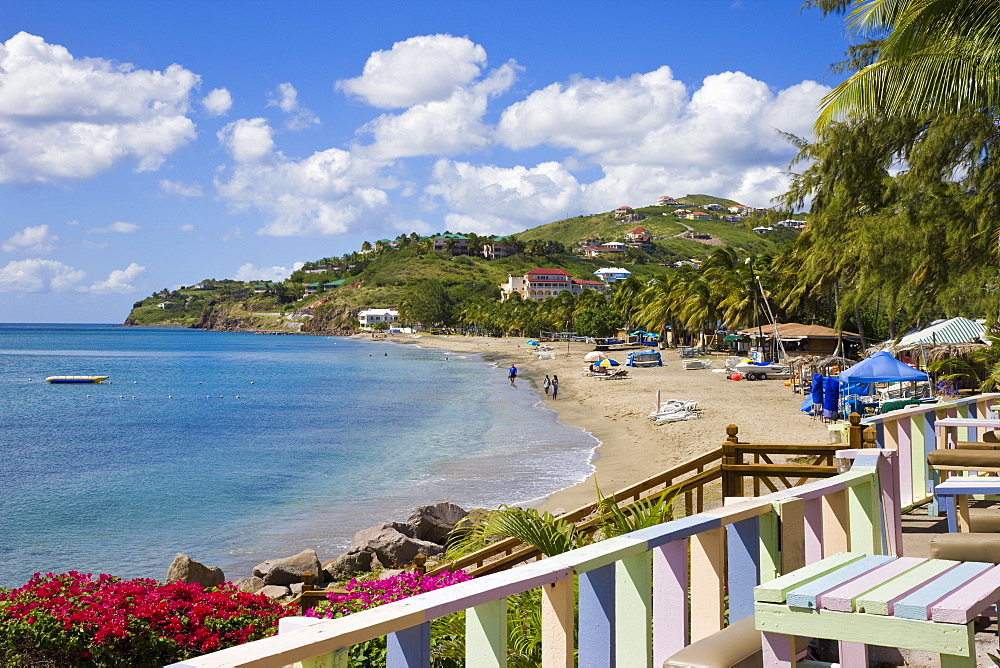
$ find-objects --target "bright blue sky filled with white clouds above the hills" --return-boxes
[0,0,847,322]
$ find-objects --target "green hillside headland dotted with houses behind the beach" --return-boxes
[126,195,797,332]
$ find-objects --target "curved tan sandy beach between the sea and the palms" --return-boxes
[374,335,829,514]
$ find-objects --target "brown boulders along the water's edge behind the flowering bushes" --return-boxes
[166,502,469,599]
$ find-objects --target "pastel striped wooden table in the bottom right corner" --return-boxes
[754,552,1000,668]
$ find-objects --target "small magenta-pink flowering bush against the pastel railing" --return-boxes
[306,571,472,618]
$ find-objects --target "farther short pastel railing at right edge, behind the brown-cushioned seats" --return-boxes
[862,393,1000,508]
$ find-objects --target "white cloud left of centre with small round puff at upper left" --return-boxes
[215,118,389,236]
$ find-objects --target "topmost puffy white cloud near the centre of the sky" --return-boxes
[337,35,486,109]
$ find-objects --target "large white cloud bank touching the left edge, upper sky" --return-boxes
[0,32,199,183]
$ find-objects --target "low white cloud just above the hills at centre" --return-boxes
[426,160,583,234]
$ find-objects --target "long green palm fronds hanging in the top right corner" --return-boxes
[817,0,1000,127]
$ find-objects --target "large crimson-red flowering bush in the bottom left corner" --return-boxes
[0,571,295,666]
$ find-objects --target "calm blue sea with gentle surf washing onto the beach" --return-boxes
[0,325,596,587]
